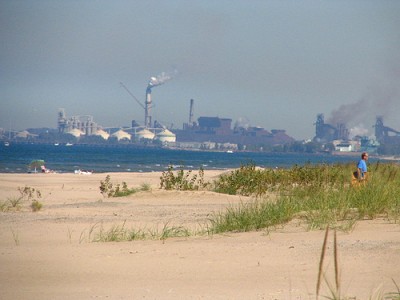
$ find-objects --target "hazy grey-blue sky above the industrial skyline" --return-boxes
[0,0,400,139]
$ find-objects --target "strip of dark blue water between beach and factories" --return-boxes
[0,144,366,173]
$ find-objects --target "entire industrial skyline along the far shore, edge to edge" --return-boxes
[0,73,400,154]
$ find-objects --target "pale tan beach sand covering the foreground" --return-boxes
[0,171,400,300]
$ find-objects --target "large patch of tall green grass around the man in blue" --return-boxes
[210,163,400,233]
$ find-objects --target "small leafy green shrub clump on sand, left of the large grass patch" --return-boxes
[160,166,209,191]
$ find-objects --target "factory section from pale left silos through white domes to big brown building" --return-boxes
[50,73,294,150]
